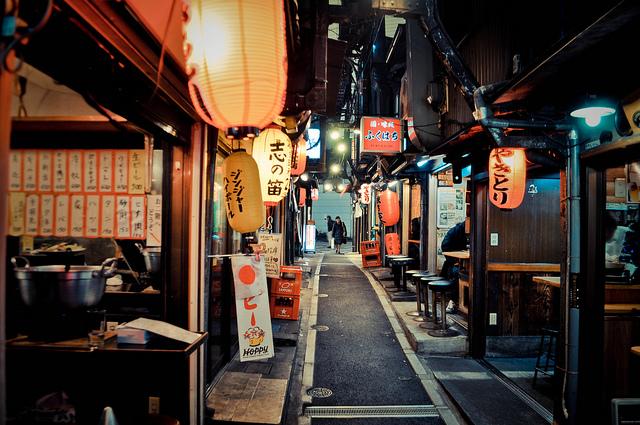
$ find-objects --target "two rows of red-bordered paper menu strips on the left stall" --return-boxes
[9,149,150,239]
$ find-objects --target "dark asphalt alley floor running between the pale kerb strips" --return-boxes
[312,252,443,425]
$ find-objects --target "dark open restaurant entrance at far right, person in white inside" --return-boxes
[578,142,640,422]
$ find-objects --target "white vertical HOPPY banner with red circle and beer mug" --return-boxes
[231,255,274,362]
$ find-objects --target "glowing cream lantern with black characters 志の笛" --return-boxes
[251,126,291,205]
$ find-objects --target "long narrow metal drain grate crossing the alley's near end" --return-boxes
[304,404,440,419]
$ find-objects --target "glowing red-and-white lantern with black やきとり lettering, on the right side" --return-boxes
[489,148,527,209]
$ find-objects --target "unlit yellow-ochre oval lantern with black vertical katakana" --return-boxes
[222,151,264,233]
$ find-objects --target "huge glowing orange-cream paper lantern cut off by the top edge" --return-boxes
[184,0,287,130]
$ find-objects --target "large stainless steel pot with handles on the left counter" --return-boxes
[11,257,118,309]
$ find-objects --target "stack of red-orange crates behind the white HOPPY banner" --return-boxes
[269,266,302,320]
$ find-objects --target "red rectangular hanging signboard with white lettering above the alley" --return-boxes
[360,117,402,154]
